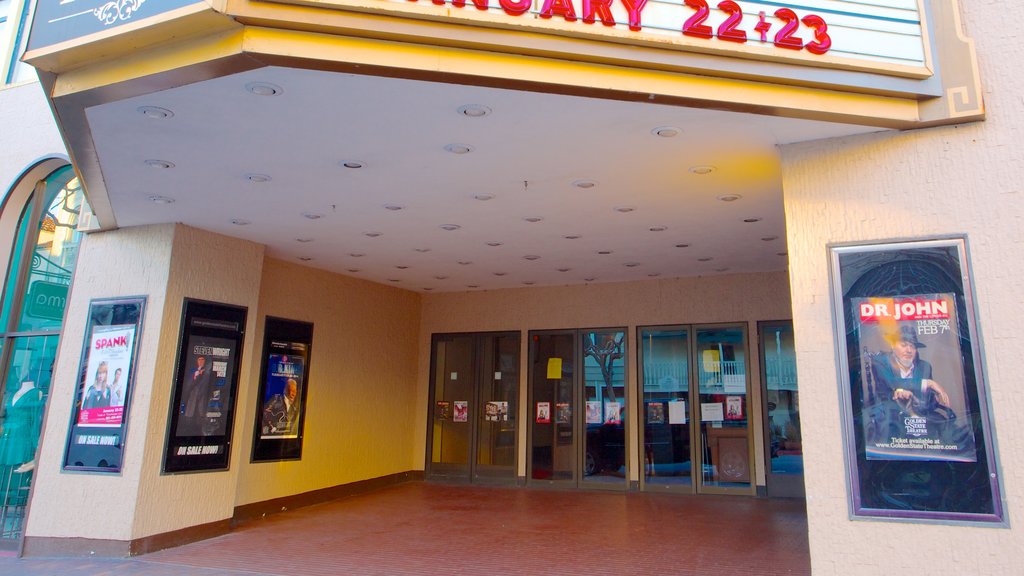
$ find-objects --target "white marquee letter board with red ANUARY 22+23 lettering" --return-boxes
[274,0,932,78]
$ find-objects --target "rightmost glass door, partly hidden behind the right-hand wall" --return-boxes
[759,321,804,498]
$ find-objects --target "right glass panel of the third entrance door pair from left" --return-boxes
[694,326,754,494]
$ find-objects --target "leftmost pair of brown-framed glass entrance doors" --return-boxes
[427,333,519,483]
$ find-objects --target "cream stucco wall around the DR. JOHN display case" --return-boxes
[782,2,1024,576]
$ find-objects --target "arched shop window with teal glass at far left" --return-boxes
[0,166,84,549]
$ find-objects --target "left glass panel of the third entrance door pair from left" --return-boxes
[639,327,693,492]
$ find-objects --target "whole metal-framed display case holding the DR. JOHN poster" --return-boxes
[830,238,1005,523]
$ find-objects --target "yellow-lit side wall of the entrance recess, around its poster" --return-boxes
[236,255,420,505]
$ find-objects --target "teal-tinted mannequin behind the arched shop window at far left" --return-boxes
[0,380,43,472]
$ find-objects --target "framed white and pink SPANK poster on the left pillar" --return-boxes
[61,296,145,474]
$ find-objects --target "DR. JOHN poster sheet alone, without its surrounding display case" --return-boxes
[851,293,977,462]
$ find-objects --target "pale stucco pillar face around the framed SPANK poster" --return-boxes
[26,224,180,540]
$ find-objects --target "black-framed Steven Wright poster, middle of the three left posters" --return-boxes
[164,298,247,472]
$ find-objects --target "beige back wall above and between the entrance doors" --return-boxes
[415,272,790,485]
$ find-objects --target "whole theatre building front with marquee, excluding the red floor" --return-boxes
[0,0,1024,574]
